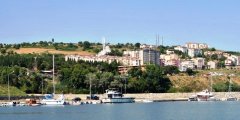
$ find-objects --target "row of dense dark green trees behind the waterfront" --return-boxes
[0,54,178,93]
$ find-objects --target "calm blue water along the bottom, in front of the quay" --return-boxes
[0,102,240,120]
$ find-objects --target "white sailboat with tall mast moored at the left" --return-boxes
[41,94,66,105]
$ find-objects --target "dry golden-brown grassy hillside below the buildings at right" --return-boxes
[169,69,240,92]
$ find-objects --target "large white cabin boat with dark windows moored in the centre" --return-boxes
[102,89,134,103]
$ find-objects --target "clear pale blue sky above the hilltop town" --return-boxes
[0,0,240,51]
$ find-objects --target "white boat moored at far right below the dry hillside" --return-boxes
[197,89,216,101]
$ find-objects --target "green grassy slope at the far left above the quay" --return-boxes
[0,85,27,96]
